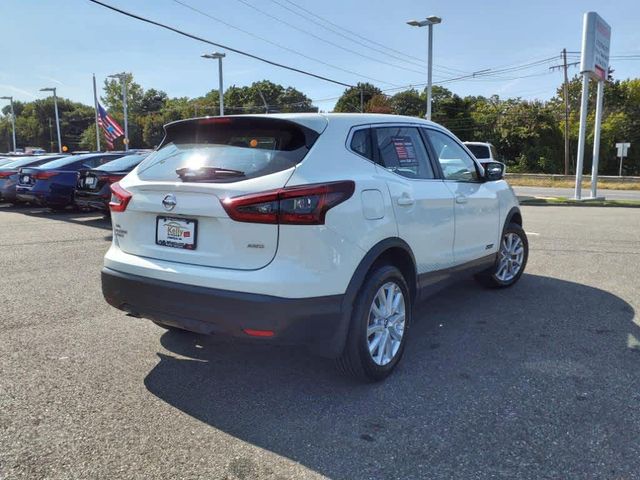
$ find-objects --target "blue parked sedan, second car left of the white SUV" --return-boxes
[16,152,125,210]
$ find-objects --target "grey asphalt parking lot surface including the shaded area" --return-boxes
[0,206,640,480]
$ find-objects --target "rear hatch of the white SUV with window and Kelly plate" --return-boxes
[113,116,326,270]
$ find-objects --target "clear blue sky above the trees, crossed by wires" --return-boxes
[0,0,640,110]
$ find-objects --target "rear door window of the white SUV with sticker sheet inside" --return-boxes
[375,127,435,179]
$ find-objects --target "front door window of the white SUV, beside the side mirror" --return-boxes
[425,129,478,182]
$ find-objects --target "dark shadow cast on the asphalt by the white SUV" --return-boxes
[144,275,640,479]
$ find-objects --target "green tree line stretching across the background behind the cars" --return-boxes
[0,75,640,175]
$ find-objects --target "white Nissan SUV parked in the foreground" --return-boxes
[102,114,528,380]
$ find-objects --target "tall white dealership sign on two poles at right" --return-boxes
[575,12,611,200]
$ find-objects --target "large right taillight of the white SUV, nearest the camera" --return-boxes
[222,180,355,225]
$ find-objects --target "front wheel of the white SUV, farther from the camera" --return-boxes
[475,223,529,288]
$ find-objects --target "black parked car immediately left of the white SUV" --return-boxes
[75,153,148,212]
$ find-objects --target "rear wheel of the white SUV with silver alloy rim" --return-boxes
[337,265,413,382]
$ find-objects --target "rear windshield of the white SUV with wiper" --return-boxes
[138,117,318,183]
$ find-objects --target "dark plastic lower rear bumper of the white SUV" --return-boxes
[102,267,349,357]
